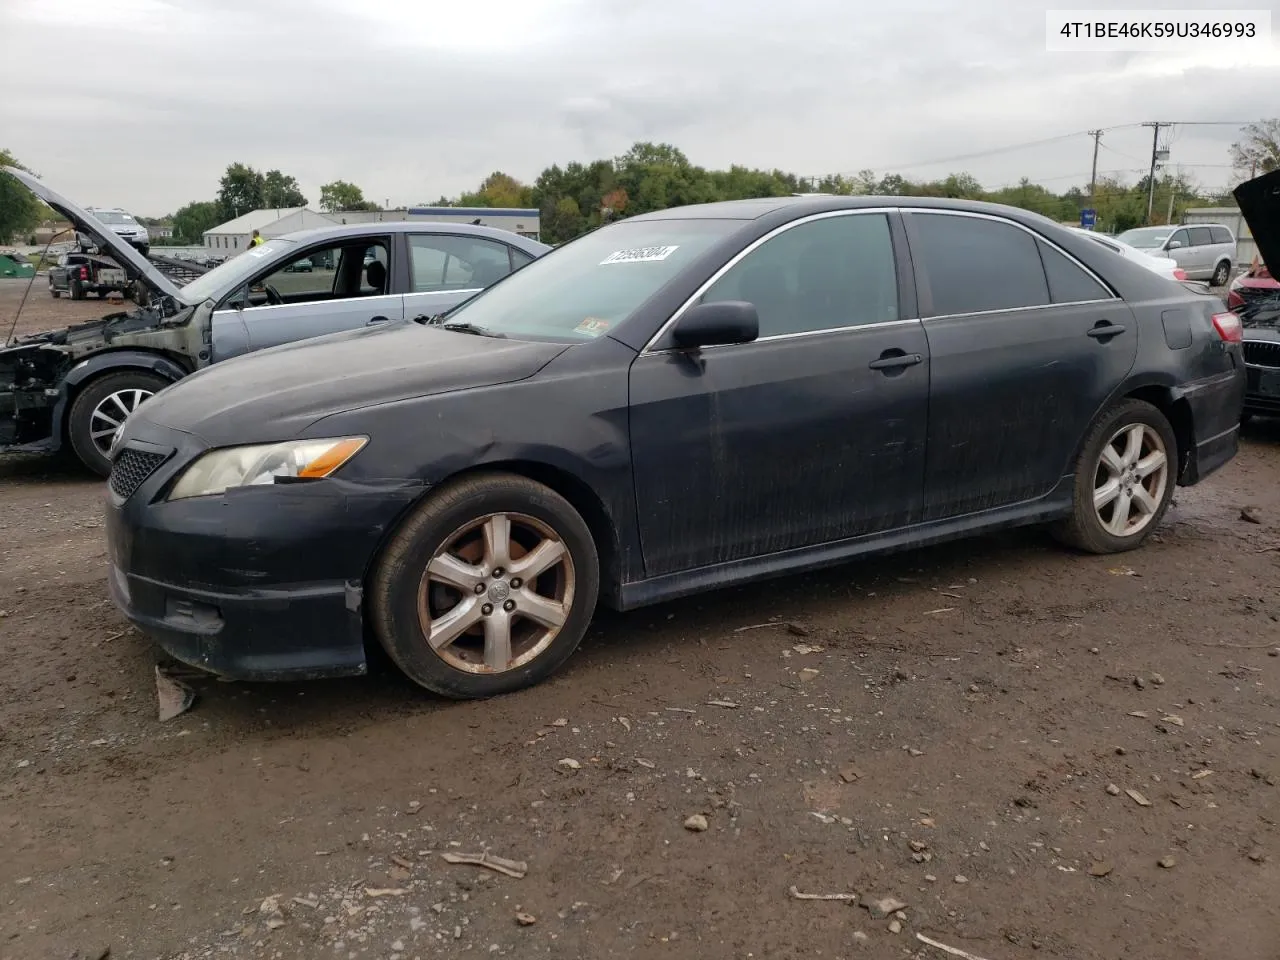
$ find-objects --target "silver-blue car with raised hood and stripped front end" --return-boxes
[0,166,550,476]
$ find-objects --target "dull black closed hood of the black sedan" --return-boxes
[136,320,568,447]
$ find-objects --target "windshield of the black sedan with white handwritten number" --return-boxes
[448,220,742,343]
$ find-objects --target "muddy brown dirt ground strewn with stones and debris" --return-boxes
[0,277,1280,960]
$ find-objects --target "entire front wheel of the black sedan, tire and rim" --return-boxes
[370,474,600,700]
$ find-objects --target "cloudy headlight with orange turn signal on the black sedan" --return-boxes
[168,436,369,500]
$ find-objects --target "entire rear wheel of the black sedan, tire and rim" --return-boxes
[1053,399,1179,553]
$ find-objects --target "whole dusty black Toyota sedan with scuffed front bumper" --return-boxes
[108,197,1244,698]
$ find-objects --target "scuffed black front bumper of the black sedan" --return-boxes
[106,425,422,680]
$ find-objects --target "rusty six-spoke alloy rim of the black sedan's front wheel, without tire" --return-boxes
[417,513,576,673]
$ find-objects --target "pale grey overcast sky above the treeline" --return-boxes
[0,0,1280,215]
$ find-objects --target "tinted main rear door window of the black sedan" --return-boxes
[910,212,1051,316]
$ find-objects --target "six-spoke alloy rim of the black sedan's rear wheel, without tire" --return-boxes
[1093,424,1169,536]
